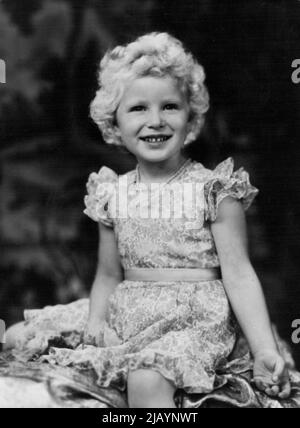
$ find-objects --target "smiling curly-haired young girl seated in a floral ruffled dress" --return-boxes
[4,33,295,408]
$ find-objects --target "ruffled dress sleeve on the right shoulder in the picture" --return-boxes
[204,157,259,221]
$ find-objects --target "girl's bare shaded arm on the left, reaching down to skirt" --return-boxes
[86,222,123,343]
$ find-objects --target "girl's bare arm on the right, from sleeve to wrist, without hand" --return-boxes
[212,197,277,356]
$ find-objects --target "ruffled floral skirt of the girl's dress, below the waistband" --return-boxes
[21,280,236,394]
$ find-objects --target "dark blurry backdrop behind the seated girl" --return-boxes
[0,0,300,365]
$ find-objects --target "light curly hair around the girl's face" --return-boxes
[90,33,209,145]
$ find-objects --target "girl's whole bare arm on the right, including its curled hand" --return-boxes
[211,197,290,398]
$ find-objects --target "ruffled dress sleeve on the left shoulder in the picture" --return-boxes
[83,166,118,227]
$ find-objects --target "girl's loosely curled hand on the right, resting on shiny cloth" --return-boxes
[253,350,291,399]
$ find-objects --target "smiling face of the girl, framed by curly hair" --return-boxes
[116,76,190,162]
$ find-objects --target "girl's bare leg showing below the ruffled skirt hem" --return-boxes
[127,370,176,409]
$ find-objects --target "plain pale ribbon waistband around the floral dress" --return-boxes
[124,268,221,282]
